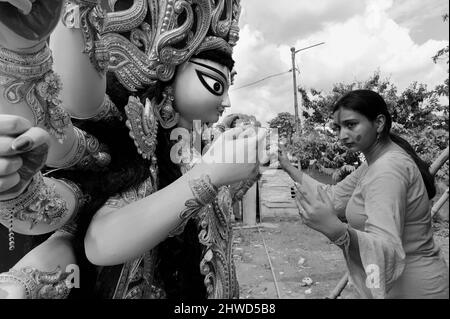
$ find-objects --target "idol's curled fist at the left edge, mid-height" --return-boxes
[0,114,50,200]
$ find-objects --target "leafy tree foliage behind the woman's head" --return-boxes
[269,71,448,179]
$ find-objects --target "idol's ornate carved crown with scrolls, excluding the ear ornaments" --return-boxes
[66,0,241,91]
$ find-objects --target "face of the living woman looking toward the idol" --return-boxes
[333,108,377,152]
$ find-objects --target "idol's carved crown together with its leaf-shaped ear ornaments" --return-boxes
[63,0,241,159]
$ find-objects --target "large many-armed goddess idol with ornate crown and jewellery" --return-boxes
[0,0,264,298]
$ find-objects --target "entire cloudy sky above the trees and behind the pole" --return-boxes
[225,0,449,125]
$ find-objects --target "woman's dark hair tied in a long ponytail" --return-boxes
[333,90,436,199]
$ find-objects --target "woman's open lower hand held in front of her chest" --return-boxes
[295,183,346,241]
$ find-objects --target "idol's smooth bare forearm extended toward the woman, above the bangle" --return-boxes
[85,165,217,266]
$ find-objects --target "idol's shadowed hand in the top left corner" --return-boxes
[0,0,64,53]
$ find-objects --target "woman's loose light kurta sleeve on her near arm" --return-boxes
[345,161,411,298]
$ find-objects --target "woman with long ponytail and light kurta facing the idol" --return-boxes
[281,90,449,298]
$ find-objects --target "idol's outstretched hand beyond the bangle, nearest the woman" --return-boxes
[202,127,266,186]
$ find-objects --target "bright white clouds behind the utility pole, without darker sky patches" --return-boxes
[230,0,448,126]
